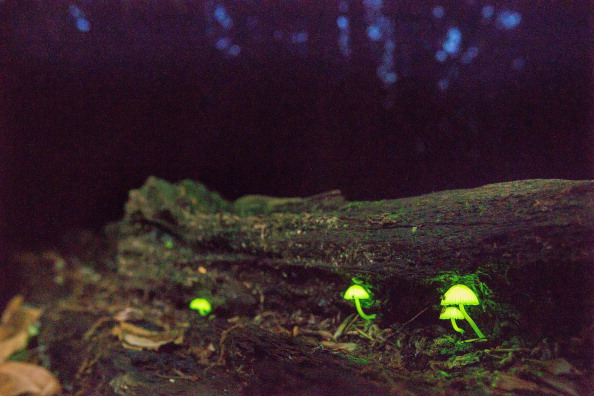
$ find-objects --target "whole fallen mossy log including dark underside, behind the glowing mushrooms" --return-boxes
[118,177,594,336]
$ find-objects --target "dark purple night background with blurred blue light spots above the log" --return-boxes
[0,0,593,241]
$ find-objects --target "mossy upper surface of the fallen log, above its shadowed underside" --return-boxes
[119,178,594,279]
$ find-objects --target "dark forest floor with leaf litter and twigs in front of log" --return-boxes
[0,233,594,395]
